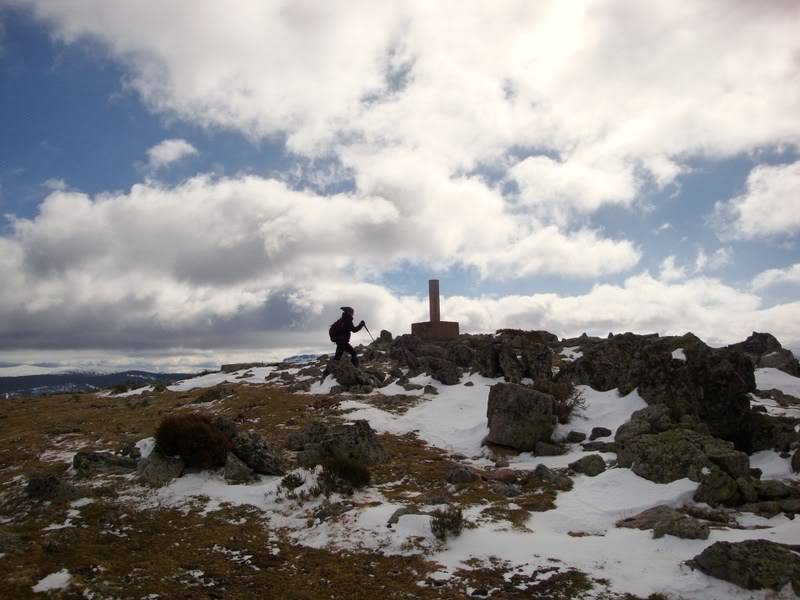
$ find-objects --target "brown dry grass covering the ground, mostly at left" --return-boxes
[0,384,604,599]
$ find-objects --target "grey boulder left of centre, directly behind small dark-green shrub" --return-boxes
[297,420,388,466]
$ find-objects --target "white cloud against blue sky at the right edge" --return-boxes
[714,161,800,239]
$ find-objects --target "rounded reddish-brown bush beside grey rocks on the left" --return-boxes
[156,413,233,469]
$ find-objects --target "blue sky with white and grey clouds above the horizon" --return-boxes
[0,0,800,370]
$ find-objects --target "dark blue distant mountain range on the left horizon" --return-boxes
[0,371,197,398]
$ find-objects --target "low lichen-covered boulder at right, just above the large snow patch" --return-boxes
[617,429,750,483]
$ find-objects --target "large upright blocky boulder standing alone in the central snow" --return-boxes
[486,383,556,451]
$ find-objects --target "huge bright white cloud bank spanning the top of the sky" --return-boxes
[15,0,800,224]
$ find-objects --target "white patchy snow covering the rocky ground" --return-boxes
[117,354,800,600]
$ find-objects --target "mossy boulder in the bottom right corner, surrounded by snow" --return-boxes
[690,540,800,594]
